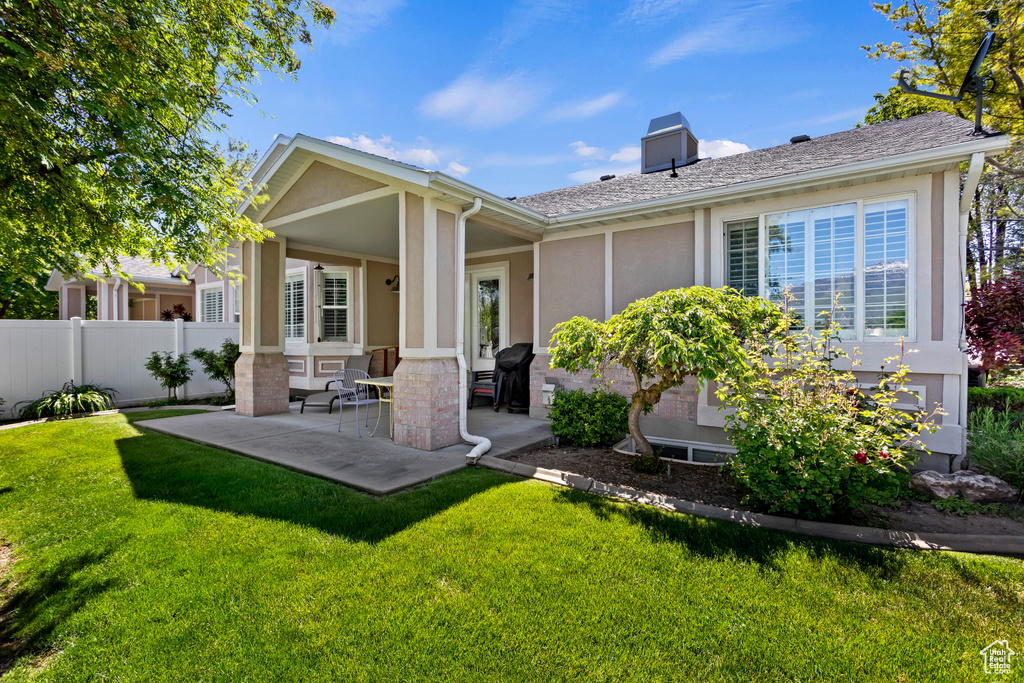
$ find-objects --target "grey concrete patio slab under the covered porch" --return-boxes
[136,403,554,496]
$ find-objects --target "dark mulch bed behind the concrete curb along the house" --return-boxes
[508,446,1024,536]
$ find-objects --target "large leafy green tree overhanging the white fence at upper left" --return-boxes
[0,0,334,290]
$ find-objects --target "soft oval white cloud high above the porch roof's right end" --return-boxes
[420,74,544,128]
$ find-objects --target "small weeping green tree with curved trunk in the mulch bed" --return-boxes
[551,287,785,458]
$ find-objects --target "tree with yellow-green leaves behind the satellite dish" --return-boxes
[863,0,1024,290]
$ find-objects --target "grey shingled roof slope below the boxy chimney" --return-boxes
[515,112,999,216]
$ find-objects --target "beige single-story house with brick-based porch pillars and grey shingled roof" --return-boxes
[226,113,1009,466]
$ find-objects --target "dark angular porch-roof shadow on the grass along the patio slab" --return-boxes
[116,432,510,544]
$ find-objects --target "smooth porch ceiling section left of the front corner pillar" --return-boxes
[274,195,398,259]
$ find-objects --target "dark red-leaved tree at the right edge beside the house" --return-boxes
[964,275,1024,373]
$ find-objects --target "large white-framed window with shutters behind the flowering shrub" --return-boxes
[724,198,912,340]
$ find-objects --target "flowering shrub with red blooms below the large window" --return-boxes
[718,303,940,518]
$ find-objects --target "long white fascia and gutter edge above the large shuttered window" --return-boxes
[548,135,1010,227]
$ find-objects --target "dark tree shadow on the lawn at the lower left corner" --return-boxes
[0,546,117,676]
